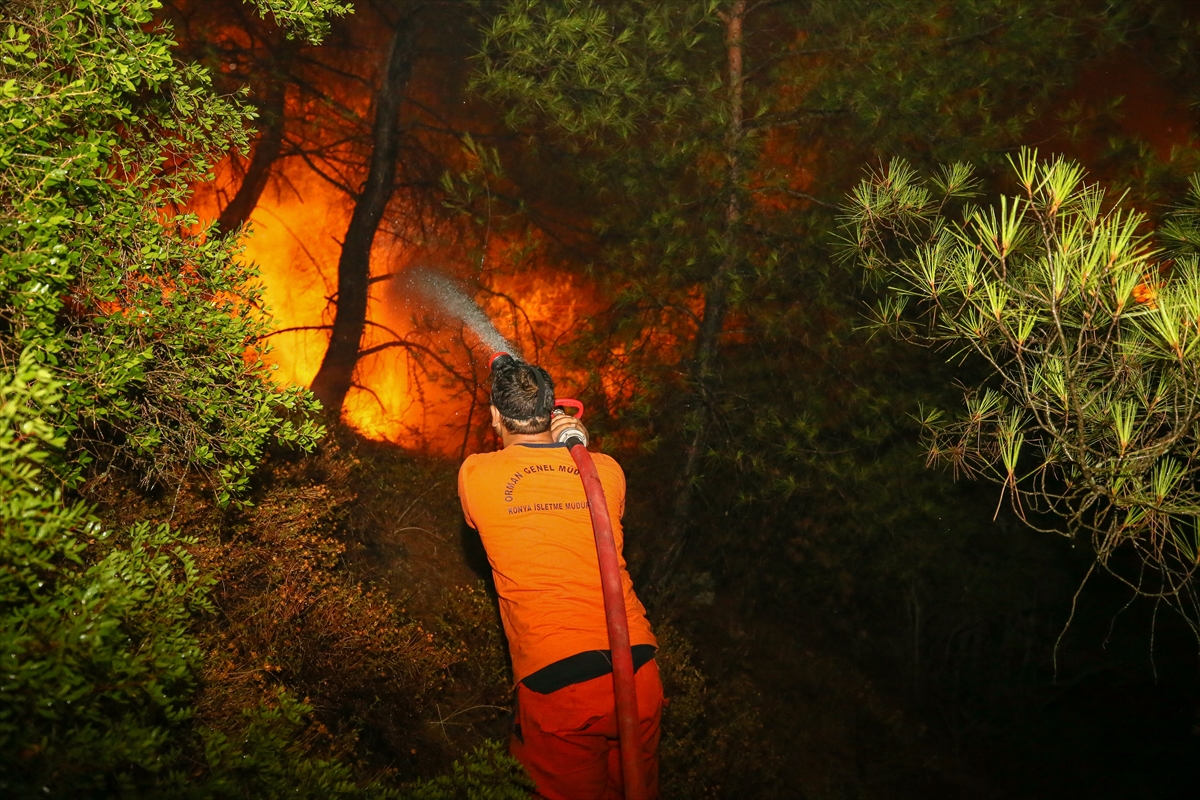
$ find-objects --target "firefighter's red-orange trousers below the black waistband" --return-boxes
[510,660,664,800]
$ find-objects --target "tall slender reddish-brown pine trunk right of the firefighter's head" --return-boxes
[646,0,746,595]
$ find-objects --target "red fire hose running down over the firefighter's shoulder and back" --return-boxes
[558,401,647,800]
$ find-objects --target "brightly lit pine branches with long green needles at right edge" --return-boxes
[846,151,1200,621]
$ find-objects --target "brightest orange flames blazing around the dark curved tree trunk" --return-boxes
[191,153,616,455]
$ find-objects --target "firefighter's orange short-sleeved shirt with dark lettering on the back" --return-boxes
[458,444,656,682]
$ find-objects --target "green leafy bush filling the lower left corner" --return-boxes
[0,351,201,796]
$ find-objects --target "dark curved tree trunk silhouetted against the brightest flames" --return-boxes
[312,12,416,416]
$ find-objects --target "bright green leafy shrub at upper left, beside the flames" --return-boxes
[0,0,325,500]
